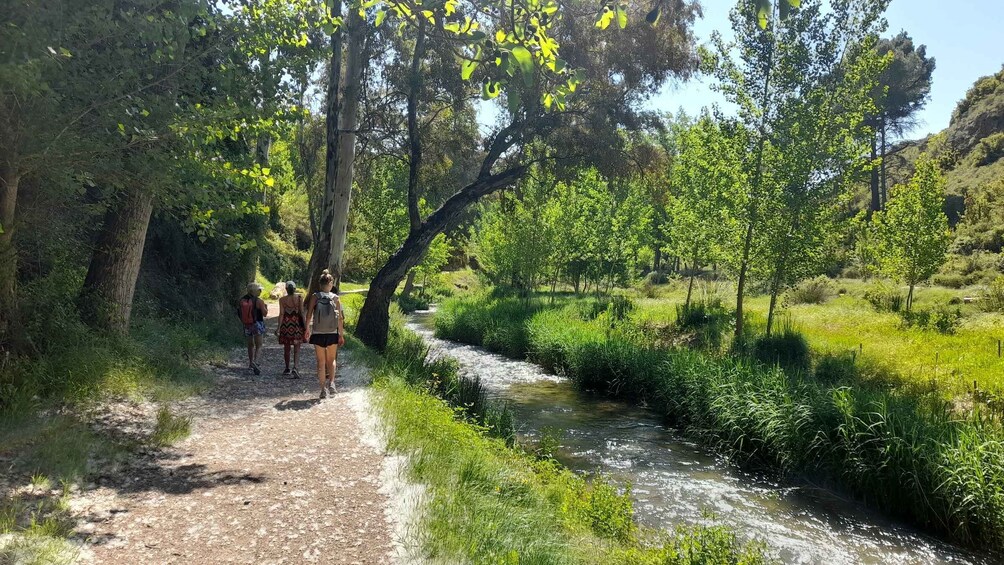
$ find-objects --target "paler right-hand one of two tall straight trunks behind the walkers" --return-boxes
[327,9,366,291]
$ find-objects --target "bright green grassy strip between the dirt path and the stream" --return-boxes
[374,319,769,565]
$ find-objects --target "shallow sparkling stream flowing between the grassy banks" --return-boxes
[409,312,997,565]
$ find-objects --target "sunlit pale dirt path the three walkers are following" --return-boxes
[74,306,393,564]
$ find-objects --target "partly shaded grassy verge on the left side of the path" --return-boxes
[0,316,235,563]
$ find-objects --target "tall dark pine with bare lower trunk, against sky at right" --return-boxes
[868,31,935,211]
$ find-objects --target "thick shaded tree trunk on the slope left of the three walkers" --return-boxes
[79,189,154,333]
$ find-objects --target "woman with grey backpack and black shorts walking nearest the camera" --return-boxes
[306,269,345,398]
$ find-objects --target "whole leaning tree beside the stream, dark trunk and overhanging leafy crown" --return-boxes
[356,0,694,349]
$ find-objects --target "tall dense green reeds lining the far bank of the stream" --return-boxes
[436,295,1004,549]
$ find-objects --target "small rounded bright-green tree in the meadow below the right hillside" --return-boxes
[866,157,952,312]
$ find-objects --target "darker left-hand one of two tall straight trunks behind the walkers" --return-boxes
[307,8,342,296]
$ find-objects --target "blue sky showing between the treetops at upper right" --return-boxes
[649,0,1004,138]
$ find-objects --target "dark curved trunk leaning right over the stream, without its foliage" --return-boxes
[355,166,525,351]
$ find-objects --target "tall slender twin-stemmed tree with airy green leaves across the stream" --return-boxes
[708,0,887,340]
